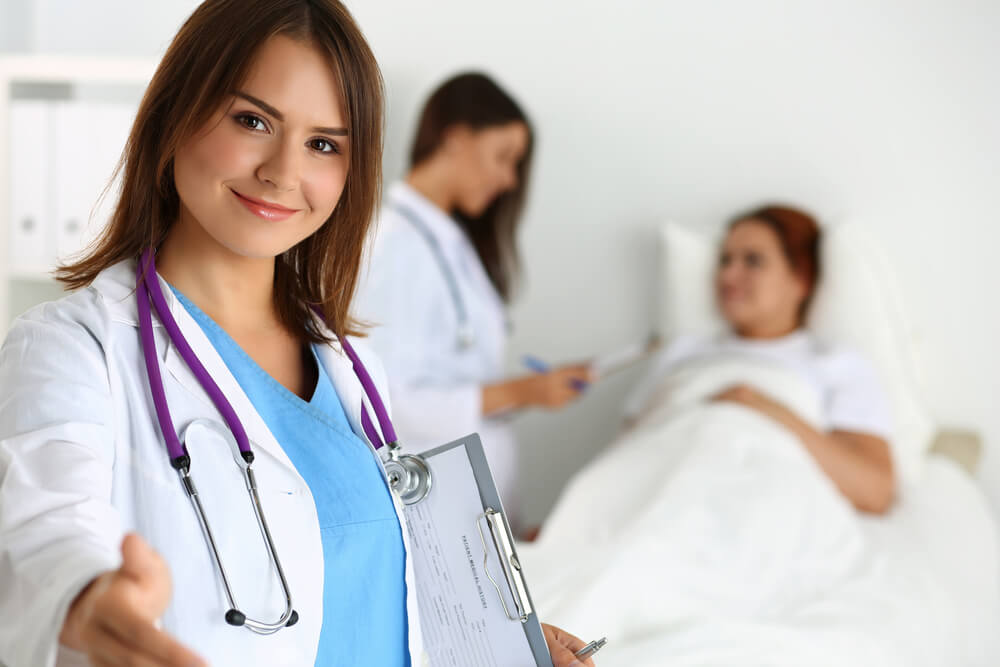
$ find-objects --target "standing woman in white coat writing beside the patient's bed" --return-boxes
[357,73,588,514]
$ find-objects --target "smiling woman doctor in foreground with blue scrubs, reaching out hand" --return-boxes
[0,0,583,667]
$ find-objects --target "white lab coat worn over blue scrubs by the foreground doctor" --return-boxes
[0,262,426,667]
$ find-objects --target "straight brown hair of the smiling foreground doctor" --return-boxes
[56,0,383,342]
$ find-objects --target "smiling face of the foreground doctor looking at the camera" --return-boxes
[174,36,350,258]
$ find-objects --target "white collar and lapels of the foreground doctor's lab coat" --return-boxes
[92,261,386,470]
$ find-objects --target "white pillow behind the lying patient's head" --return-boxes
[660,222,935,483]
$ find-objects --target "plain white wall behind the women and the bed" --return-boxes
[0,0,1000,532]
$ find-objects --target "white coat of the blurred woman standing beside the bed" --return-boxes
[355,182,517,514]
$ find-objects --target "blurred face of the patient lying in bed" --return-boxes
[715,220,806,338]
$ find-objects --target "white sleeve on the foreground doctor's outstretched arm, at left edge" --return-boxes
[0,297,121,667]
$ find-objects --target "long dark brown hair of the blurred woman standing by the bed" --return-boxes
[410,72,535,303]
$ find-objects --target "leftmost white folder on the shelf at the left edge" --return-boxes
[9,100,55,272]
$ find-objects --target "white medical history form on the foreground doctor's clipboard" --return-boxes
[405,438,551,667]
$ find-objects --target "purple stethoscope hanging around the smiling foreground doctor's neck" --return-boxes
[135,250,432,635]
